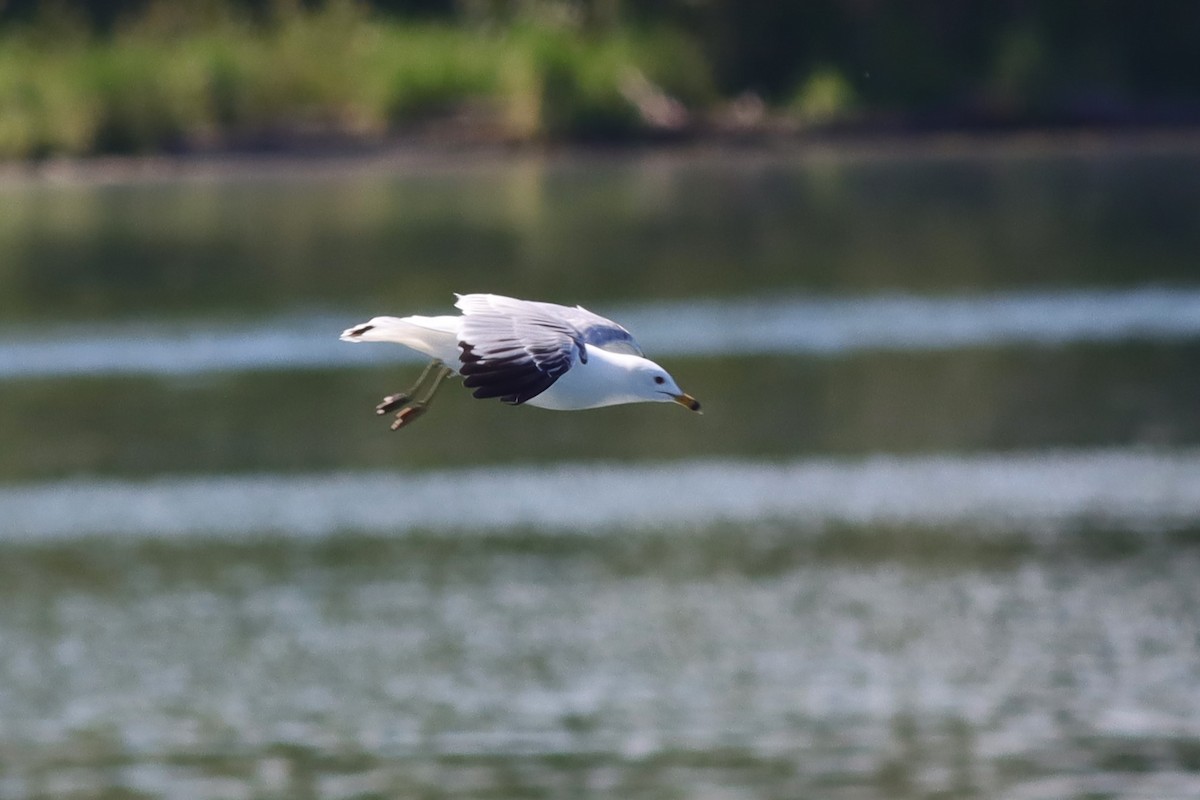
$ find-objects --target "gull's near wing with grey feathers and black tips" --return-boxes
[455,294,587,404]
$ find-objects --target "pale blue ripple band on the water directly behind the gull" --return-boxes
[0,288,1200,378]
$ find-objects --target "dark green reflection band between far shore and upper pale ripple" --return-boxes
[0,146,1200,321]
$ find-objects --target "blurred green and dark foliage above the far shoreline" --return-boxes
[0,0,1200,158]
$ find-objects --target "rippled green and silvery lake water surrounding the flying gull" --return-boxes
[0,146,1200,800]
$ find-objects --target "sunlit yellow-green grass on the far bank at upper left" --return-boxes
[0,2,714,160]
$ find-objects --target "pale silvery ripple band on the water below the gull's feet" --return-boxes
[0,450,1200,542]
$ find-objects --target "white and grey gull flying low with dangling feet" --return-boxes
[341,294,700,431]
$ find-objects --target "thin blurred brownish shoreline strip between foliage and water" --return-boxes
[0,126,1200,187]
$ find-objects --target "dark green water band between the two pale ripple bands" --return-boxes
[0,343,1200,480]
